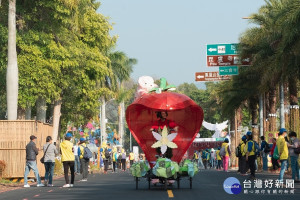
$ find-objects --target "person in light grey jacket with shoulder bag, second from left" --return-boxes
[43,136,58,187]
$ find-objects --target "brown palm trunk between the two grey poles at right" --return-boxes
[269,87,277,132]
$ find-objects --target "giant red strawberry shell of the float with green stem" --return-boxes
[126,79,203,166]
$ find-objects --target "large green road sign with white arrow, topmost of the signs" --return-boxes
[206,44,238,56]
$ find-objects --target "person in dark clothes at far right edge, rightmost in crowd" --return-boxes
[288,132,300,183]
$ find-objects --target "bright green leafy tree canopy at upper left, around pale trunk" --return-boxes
[0,0,116,130]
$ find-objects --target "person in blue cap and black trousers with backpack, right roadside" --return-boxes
[245,131,256,180]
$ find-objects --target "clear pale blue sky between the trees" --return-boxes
[98,0,264,87]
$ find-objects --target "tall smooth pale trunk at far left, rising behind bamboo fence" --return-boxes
[6,0,19,120]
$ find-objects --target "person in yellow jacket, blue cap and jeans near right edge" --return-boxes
[276,128,289,181]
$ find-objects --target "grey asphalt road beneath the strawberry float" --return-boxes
[0,170,300,200]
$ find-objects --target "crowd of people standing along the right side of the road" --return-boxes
[193,128,300,183]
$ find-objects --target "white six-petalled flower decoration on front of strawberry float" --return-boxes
[151,126,178,154]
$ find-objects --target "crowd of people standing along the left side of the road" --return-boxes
[24,133,138,188]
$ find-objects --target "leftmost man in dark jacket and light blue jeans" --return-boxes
[24,135,44,188]
